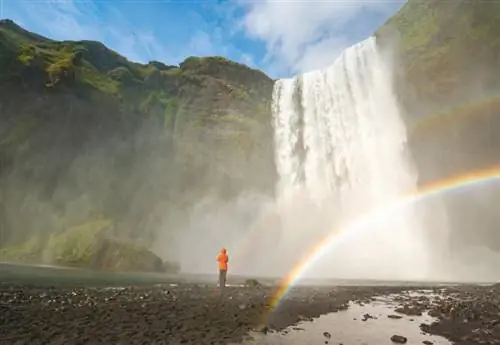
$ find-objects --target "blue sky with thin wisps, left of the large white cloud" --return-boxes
[7,0,262,66]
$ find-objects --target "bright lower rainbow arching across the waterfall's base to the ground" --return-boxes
[268,165,500,311]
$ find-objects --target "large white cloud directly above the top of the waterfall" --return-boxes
[239,0,403,74]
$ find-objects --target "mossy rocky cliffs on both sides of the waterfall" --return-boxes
[0,0,500,268]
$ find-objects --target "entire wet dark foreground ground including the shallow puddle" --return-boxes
[0,283,500,345]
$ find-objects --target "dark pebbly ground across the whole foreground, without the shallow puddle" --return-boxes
[0,284,500,345]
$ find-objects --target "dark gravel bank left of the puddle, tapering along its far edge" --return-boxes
[0,284,410,344]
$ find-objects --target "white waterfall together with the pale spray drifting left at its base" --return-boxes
[156,35,448,280]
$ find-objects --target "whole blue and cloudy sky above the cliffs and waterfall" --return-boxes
[0,0,406,78]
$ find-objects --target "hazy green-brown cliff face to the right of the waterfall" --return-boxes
[377,0,500,249]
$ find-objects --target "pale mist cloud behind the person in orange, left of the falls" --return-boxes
[155,193,276,274]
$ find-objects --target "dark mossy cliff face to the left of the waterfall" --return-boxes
[0,20,275,264]
